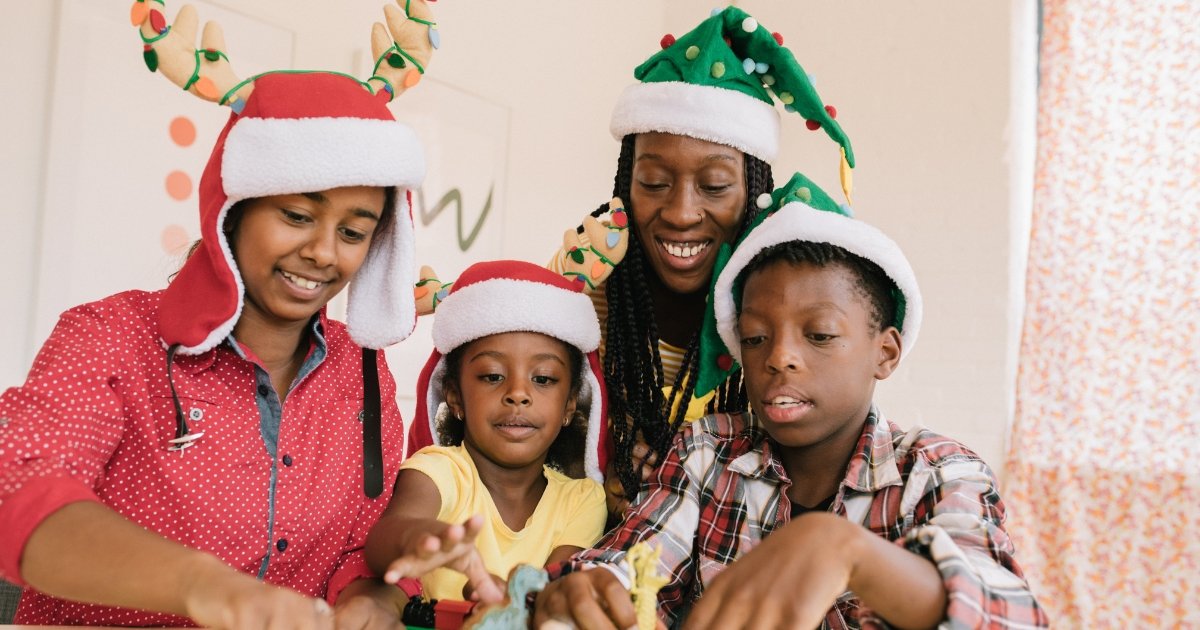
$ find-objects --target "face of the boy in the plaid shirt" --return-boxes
[737,260,900,452]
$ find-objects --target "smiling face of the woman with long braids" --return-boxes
[630,133,746,294]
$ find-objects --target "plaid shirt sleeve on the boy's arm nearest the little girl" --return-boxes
[551,422,714,626]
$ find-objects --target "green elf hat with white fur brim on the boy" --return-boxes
[695,173,923,396]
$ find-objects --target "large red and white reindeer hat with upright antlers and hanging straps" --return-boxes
[130,0,439,496]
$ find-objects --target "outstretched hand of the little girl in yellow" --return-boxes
[383,514,504,604]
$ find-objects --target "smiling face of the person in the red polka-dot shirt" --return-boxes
[229,186,385,338]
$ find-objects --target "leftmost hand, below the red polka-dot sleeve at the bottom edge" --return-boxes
[177,557,334,630]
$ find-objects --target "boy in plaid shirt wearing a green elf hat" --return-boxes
[534,174,1048,628]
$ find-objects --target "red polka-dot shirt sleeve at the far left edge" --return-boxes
[0,305,133,584]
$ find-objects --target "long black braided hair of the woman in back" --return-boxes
[598,134,774,497]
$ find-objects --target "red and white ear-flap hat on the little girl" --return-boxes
[407,260,607,482]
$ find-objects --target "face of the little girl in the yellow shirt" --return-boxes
[444,332,578,468]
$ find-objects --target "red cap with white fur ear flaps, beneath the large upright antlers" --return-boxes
[160,72,425,354]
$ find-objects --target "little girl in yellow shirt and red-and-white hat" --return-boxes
[366,260,606,601]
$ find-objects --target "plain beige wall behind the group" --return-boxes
[0,0,1028,468]
